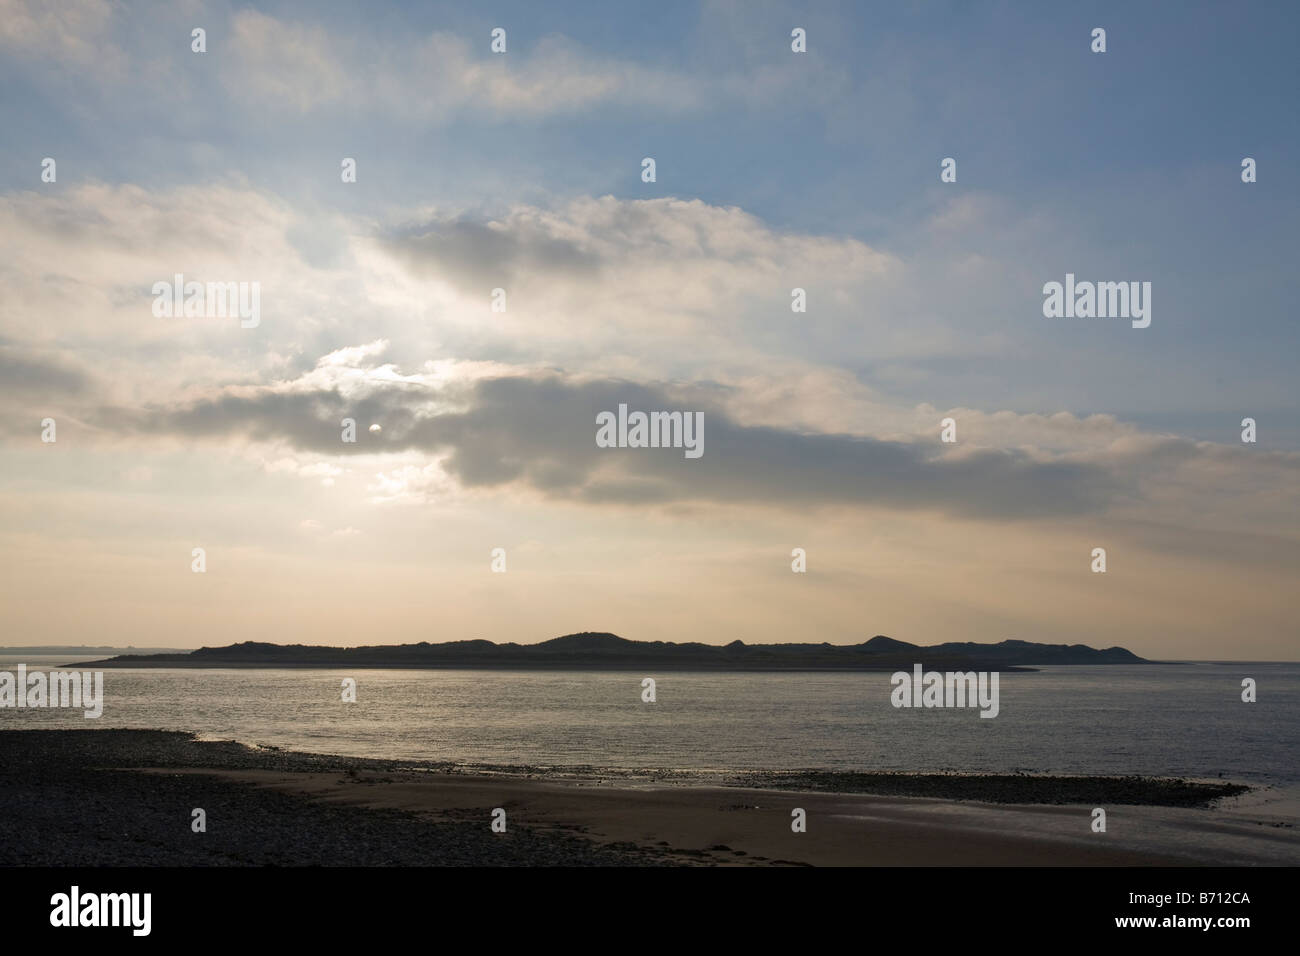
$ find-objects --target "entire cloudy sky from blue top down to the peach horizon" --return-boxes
[0,0,1300,659]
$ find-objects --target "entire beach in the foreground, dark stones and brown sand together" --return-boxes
[0,730,1300,866]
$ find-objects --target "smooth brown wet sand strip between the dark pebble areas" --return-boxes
[159,770,1186,866]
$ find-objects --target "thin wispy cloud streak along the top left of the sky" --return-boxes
[0,0,853,125]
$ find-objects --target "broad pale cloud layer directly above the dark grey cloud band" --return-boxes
[0,182,1024,408]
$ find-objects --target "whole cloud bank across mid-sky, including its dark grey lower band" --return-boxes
[0,183,1295,538]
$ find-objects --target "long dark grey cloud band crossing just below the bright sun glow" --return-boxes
[114,375,1135,519]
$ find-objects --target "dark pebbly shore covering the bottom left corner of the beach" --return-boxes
[0,730,660,866]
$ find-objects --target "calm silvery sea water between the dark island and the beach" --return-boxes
[0,653,1300,790]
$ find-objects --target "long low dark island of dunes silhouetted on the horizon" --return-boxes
[76,632,1144,671]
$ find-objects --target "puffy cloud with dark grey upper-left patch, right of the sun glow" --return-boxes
[376,196,904,375]
